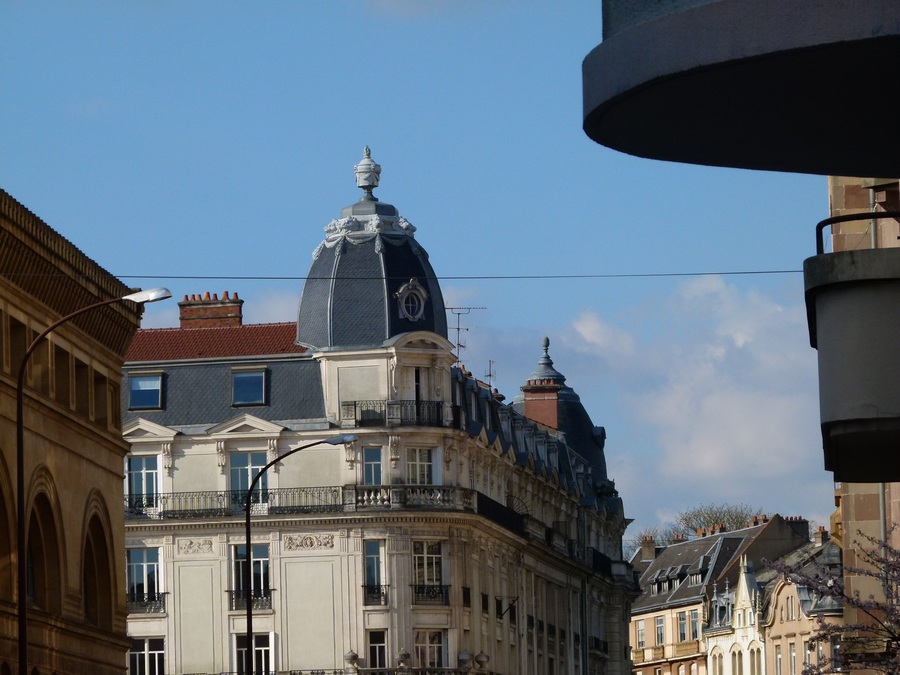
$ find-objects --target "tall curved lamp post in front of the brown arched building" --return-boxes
[16,288,172,675]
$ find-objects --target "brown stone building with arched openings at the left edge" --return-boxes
[0,190,141,675]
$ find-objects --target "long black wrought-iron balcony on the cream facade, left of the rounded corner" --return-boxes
[125,487,343,520]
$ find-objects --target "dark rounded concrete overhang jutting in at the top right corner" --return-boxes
[583,0,900,176]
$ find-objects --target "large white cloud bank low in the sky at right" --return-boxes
[568,277,832,527]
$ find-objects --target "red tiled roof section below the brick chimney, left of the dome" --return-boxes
[125,323,306,363]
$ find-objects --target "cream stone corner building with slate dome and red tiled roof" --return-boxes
[123,149,636,675]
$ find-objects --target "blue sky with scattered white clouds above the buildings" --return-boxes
[0,0,833,530]
